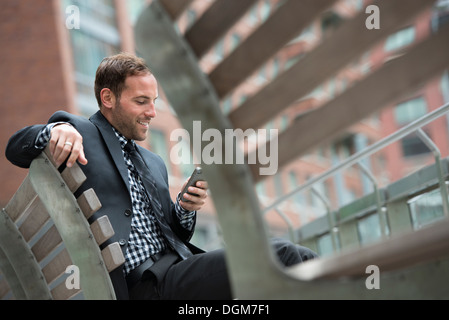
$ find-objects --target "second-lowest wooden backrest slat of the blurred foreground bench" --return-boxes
[229,0,434,130]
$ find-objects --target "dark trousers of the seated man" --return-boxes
[129,239,317,300]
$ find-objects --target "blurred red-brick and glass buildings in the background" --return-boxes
[0,0,449,254]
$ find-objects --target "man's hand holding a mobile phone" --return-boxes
[179,167,208,211]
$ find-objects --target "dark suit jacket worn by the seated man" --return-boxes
[6,111,202,299]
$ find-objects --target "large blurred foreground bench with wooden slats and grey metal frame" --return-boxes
[135,0,449,299]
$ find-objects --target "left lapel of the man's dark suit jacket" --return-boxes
[89,111,130,190]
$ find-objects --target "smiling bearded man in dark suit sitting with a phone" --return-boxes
[6,53,316,299]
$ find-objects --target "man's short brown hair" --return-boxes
[95,53,151,108]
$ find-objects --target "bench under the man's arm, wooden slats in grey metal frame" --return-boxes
[0,148,124,300]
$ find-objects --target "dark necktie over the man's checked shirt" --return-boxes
[125,141,192,259]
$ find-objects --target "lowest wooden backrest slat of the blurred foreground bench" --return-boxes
[251,26,449,180]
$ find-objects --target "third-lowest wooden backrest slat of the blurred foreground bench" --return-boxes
[209,0,335,98]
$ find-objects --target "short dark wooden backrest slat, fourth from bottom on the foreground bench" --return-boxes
[185,0,256,58]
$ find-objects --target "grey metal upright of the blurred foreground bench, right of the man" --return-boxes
[135,1,284,297]
